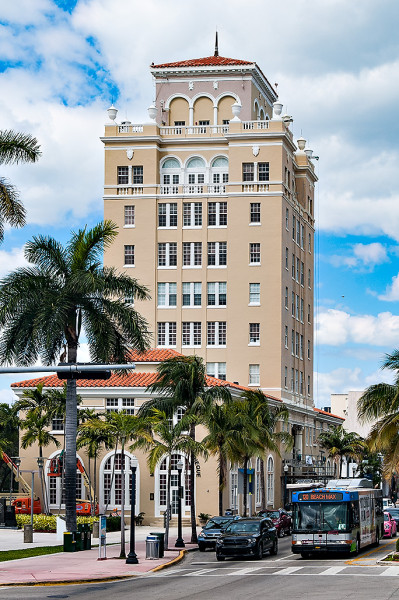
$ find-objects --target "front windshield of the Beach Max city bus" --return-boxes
[294,502,349,531]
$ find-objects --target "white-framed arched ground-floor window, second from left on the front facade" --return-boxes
[101,451,140,514]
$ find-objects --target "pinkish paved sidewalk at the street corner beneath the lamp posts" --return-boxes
[0,527,197,586]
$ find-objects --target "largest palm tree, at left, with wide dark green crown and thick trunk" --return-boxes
[0,221,150,531]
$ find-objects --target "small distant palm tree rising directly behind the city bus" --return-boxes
[319,425,367,477]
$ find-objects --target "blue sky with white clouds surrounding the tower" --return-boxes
[0,0,399,406]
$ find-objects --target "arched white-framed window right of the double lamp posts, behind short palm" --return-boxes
[157,453,191,515]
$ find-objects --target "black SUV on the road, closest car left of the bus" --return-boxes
[216,517,278,560]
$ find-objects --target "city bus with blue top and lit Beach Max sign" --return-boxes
[292,479,384,558]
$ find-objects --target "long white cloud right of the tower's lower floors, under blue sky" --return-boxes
[315,309,399,347]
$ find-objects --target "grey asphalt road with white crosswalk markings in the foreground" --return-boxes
[0,538,399,600]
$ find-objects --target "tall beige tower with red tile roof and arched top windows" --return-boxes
[102,52,316,408]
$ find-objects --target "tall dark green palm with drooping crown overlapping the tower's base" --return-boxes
[140,356,230,543]
